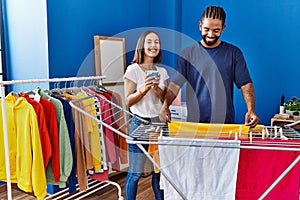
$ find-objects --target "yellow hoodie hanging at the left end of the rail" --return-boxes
[0,93,47,199]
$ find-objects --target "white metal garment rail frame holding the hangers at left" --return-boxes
[0,76,129,200]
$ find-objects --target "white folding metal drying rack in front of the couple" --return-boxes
[70,95,300,199]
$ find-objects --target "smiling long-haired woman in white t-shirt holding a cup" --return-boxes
[124,31,169,200]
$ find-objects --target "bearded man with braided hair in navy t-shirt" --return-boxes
[159,6,259,127]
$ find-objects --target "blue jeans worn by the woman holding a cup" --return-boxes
[125,117,164,200]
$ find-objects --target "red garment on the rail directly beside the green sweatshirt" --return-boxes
[40,97,60,182]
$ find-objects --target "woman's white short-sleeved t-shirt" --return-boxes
[124,63,169,118]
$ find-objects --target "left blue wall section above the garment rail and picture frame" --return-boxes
[47,0,150,77]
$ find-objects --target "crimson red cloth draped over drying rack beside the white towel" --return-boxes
[236,140,300,200]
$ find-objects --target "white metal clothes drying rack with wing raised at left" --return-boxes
[70,94,300,199]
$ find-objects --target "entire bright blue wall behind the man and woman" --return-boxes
[8,0,300,125]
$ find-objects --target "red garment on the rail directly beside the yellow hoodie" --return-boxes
[20,93,52,171]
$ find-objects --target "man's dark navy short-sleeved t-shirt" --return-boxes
[171,42,252,123]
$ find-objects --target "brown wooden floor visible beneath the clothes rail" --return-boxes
[0,172,155,200]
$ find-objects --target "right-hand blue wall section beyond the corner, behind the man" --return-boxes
[176,0,300,125]
